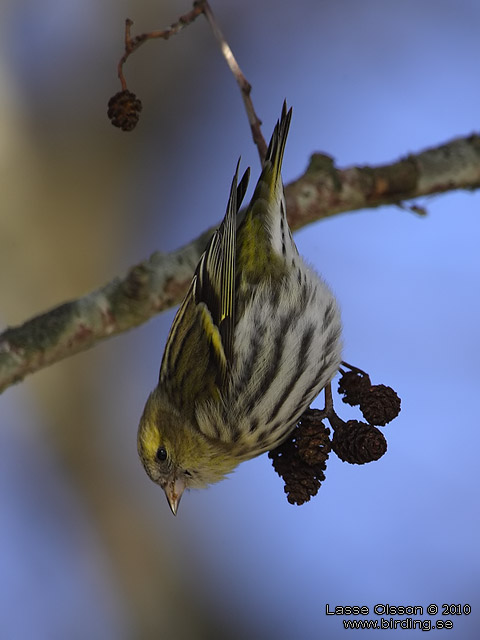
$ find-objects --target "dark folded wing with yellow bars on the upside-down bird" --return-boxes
[160,164,249,402]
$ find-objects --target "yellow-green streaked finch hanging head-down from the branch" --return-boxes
[137,102,342,515]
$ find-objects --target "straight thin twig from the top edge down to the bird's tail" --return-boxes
[201,0,267,164]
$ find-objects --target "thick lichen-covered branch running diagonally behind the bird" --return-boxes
[0,135,480,392]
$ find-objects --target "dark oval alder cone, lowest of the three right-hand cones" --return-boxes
[332,420,387,464]
